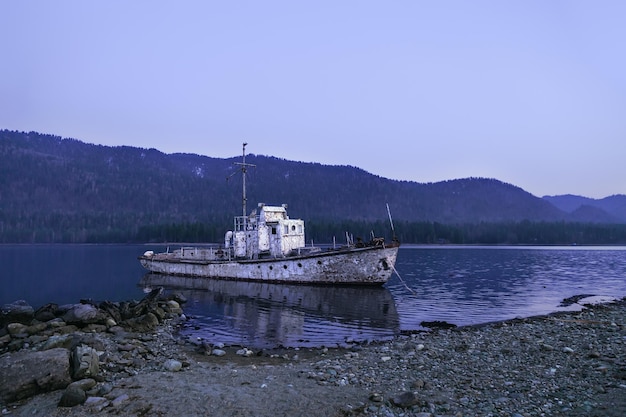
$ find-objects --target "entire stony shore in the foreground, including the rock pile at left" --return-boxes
[0,292,626,417]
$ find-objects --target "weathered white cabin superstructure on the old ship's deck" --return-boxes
[224,203,306,259]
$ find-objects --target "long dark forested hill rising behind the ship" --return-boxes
[0,130,626,242]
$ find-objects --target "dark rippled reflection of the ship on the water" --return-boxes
[140,273,400,348]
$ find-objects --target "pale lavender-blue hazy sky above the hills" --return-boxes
[0,0,626,198]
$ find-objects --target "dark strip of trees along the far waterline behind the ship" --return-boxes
[0,213,626,245]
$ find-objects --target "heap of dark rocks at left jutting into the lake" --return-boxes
[0,288,185,407]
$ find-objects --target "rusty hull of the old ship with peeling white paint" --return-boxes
[139,245,398,285]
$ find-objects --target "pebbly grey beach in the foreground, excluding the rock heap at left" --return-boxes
[0,299,626,417]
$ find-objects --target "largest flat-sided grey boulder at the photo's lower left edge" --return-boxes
[0,348,72,402]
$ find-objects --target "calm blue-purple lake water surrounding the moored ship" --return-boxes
[0,245,626,348]
